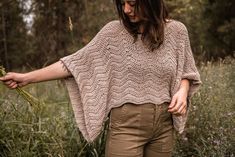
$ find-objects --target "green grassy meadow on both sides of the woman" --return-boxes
[0,58,235,157]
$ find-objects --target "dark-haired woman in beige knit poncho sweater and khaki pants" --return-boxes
[0,0,201,157]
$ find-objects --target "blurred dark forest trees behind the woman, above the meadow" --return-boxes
[0,0,235,70]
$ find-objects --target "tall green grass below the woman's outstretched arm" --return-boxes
[0,81,107,157]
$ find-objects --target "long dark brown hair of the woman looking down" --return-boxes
[114,0,168,51]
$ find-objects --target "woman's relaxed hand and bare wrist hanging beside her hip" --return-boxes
[168,80,189,116]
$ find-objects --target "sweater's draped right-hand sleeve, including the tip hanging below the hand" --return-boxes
[171,22,201,133]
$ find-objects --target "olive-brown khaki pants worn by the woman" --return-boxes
[105,103,173,157]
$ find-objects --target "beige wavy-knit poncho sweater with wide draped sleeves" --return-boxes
[61,20,201,142]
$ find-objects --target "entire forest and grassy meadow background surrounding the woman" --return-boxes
[0,0,235,157]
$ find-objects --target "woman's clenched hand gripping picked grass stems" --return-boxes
[0,72,30,89]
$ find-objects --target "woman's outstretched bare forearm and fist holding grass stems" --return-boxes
[0,61,71,89]
